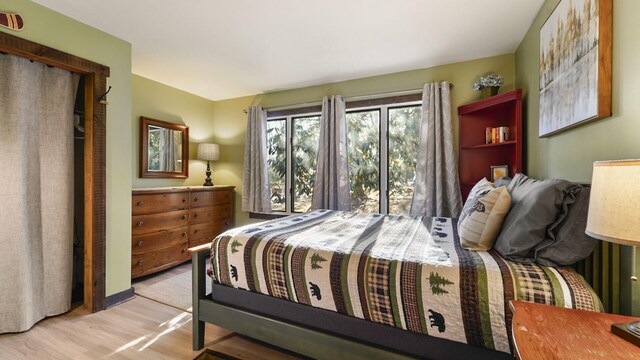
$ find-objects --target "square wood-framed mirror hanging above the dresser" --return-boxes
[140,116,189,179]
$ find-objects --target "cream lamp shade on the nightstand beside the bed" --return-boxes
[586,160,640,246]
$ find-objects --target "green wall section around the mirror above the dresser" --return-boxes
[130,75,218,188]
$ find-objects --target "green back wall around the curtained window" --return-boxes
[213,54,515,224]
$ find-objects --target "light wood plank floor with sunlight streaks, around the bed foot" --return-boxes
[0,296,296,360]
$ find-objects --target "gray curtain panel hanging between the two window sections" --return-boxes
[311,96,351,211]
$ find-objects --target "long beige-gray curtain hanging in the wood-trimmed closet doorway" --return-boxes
[0,55,79,333]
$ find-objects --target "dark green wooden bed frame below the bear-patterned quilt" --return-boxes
[189,244,512,360]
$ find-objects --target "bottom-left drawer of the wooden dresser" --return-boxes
[131,242,191,278]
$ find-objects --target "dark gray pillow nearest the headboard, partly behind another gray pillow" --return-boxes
[535,186,596,266]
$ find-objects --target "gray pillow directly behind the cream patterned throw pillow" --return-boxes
[494,174,577,263]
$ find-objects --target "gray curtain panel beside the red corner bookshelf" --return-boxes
[410,81,462,217]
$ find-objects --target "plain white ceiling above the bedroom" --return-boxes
[34,0,544,100]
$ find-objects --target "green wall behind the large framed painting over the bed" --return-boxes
[515,0,640,316]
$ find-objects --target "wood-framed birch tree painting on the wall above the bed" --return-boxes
[538,0,612,137]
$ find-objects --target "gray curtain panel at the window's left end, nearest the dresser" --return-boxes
[242,106,271,212]
